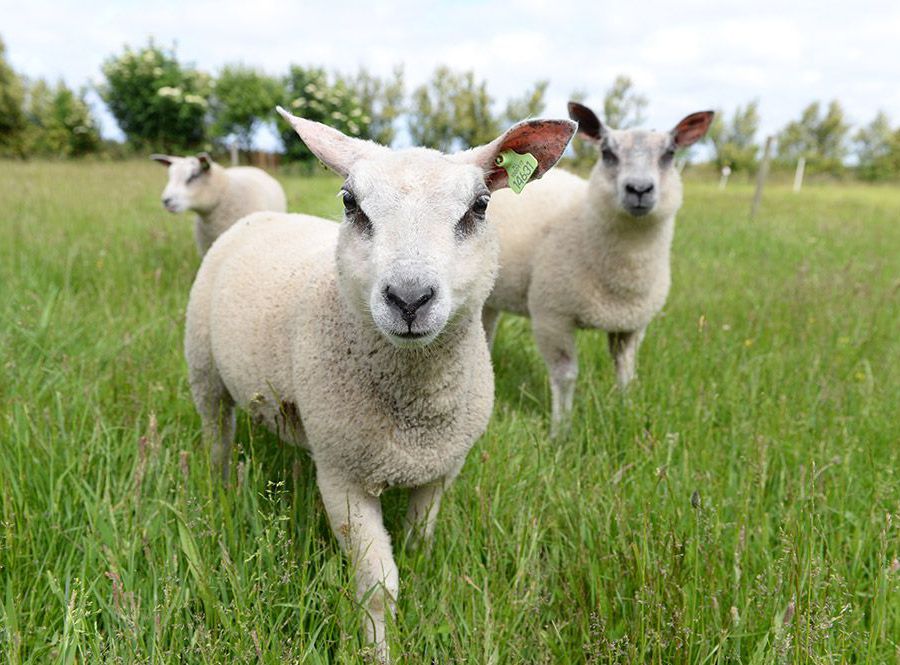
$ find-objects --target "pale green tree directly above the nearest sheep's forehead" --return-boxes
[409,66,500,152]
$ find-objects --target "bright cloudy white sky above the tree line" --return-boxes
[0,0,900,148]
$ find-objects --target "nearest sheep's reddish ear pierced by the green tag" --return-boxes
[452,119,577,191]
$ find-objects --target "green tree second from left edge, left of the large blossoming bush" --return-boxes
[25,79,101,157]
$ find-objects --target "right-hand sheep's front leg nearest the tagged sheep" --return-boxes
[532,317,578,438]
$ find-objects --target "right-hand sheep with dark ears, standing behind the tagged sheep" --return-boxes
[483,102,713,437]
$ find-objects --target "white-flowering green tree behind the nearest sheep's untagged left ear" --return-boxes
[279,65,372,162]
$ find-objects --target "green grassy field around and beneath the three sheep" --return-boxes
[0,163,900,665]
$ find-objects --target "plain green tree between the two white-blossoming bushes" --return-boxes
[210,65,284,150]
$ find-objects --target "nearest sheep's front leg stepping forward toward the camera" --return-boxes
[317,466,400,662]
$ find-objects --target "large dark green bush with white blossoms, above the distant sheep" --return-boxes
[98,40,212,152]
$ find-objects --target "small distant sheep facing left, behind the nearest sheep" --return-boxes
[150,152,287,256]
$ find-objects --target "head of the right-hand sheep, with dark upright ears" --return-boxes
[569,102,713,220]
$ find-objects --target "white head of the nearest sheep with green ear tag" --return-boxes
[278,108,576,346]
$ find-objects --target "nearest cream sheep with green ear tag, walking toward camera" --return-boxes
[185,107,576,661]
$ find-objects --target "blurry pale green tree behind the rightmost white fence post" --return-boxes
[778,100,850,173]
